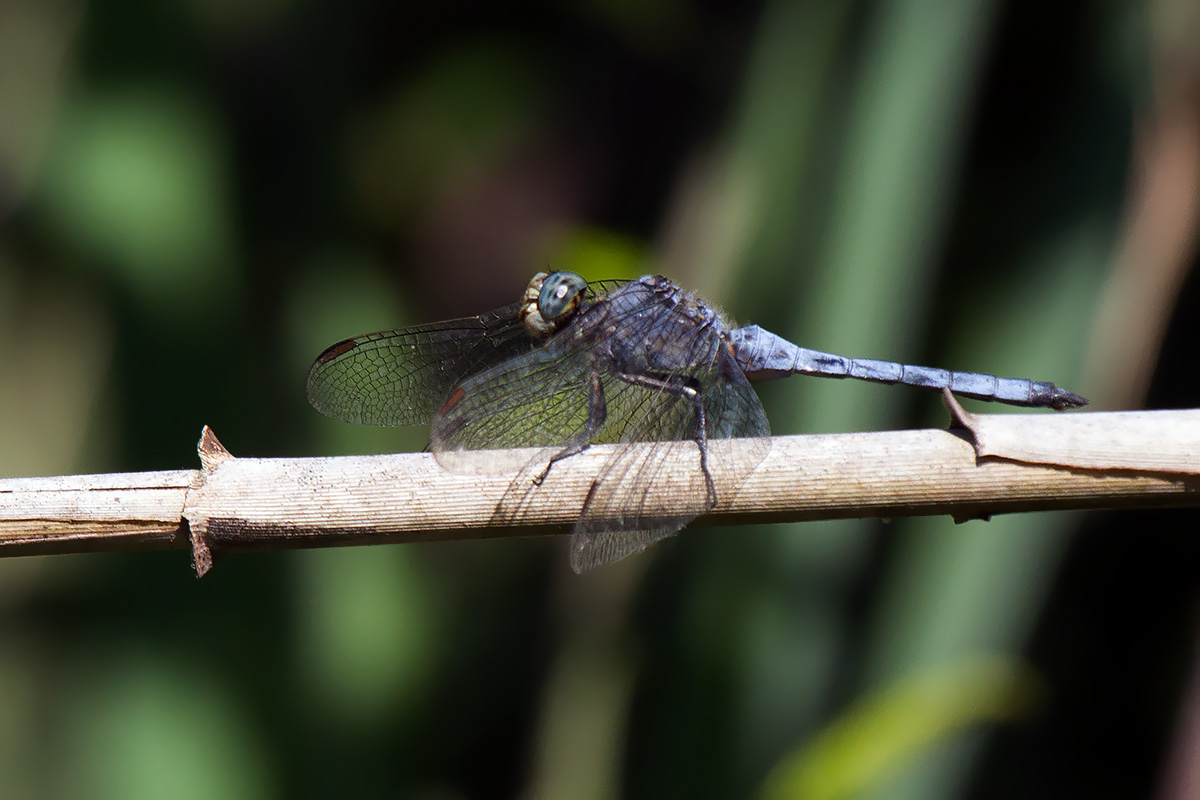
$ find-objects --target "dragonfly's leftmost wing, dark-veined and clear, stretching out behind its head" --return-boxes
[308,303,534,426]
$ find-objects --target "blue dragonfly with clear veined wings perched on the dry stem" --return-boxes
[307,272,1087,572]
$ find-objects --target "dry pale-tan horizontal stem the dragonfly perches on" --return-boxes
[0,408,1200,575]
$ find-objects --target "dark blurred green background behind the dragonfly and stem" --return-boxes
[0,0,1200,799]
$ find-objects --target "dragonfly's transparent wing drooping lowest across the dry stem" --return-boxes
[570,351,770,572]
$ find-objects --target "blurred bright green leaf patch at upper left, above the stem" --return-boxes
[40,89,233,314]
